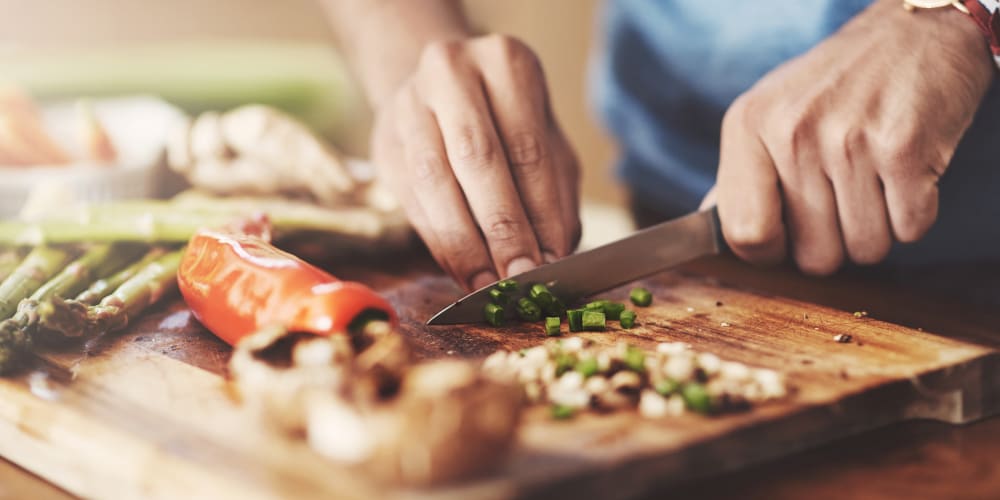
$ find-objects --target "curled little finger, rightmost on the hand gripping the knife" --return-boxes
[882,168,938,243]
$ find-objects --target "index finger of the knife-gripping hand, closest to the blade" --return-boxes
[716,104,785,264]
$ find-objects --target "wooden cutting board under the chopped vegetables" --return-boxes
[0,259,1000,499]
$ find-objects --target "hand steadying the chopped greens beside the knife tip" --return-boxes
[371,35,580,288]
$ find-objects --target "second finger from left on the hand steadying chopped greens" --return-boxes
[423,59,541,276]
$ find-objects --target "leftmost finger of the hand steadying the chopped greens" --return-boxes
[396,88,497,288]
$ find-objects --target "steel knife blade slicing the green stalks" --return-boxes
[427,207,726,325]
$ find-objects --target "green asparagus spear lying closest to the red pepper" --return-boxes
[38,249,183,337]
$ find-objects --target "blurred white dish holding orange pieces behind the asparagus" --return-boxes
[0,96,184,218]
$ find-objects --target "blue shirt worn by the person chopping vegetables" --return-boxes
[592,0,1000,264]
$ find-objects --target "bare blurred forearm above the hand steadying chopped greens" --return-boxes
[322,0,468,107]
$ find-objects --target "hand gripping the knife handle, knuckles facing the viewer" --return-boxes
[705,0,994,275]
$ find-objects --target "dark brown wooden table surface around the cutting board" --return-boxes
[0,256,1000,499]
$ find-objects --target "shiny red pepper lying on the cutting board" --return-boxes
[177,231,398,345]
